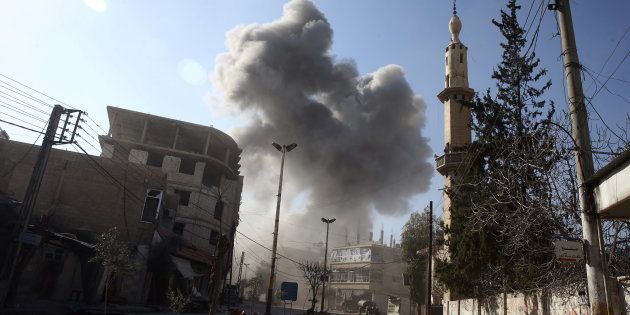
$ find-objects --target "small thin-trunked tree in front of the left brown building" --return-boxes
[90,227,135,314]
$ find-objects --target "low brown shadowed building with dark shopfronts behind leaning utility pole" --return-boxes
[0,140,166,303]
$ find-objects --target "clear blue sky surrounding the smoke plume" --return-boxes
[0,0,630,272]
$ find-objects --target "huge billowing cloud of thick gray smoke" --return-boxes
[215,0,433,244]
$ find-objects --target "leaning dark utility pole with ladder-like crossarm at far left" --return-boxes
[0,105,82,306]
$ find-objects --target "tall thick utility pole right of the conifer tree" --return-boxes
[549,0,609,315]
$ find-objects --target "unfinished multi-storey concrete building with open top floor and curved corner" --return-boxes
[99,106,243,251]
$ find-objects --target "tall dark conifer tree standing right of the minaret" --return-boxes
[438,0,576,297]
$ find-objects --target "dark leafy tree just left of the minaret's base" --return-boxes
[401,209,444,304]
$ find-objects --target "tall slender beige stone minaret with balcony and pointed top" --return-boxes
[435,2,475,242]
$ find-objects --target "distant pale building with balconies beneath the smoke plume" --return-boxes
[329,242,411,315]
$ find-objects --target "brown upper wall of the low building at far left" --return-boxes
[0,140,165,244]
